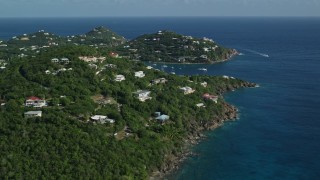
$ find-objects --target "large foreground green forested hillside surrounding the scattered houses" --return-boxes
[0,45,254,179]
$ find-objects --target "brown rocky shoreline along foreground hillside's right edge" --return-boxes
[149,82,257,180]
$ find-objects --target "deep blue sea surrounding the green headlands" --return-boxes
[0,18,320,180]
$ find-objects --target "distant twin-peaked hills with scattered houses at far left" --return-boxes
[0,27,126,59]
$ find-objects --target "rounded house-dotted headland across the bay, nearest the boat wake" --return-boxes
[118,31,237,63]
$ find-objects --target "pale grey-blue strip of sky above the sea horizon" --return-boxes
[0,0,320,17]
